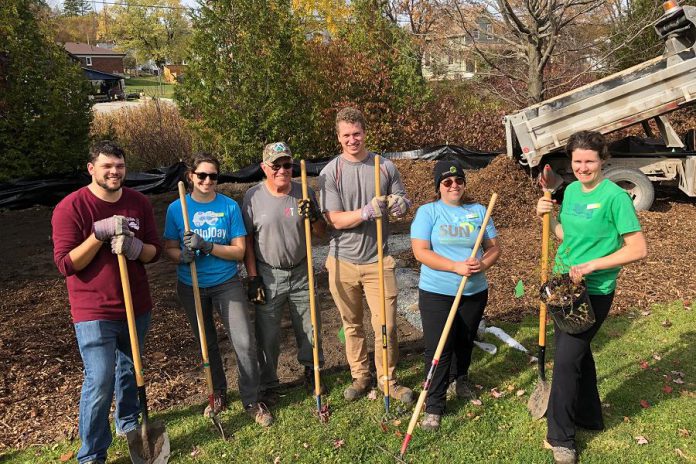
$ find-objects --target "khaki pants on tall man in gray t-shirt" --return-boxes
[326,256,399,388]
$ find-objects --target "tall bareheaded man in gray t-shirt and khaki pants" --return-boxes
[319,108,413,403]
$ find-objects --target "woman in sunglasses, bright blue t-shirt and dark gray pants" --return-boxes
[164,153,273,426]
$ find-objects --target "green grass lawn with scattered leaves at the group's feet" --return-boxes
[0,302,696,464]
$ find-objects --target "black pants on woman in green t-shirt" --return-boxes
[546,293,614,449]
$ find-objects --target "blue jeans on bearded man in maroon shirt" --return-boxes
[75,312,151,463]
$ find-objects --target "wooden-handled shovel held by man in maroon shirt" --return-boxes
[117,254,170,464]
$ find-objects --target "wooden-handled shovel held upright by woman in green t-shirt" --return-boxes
[527,164,562,420]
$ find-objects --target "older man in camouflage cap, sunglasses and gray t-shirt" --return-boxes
[242,142,326,405]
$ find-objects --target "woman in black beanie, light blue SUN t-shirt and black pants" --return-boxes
[411,160,500,430]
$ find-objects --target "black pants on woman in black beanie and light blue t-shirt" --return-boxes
[418,290,488,415]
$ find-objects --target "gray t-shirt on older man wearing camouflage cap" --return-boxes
[242,181,317,268]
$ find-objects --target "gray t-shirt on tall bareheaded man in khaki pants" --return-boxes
[319,153,406,264]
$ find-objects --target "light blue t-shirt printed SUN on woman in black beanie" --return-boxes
[411,200,498,296]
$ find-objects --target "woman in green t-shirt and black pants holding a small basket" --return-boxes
[536,131,647,463]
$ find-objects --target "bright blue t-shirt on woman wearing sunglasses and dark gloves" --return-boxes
[164,193,246,288]
